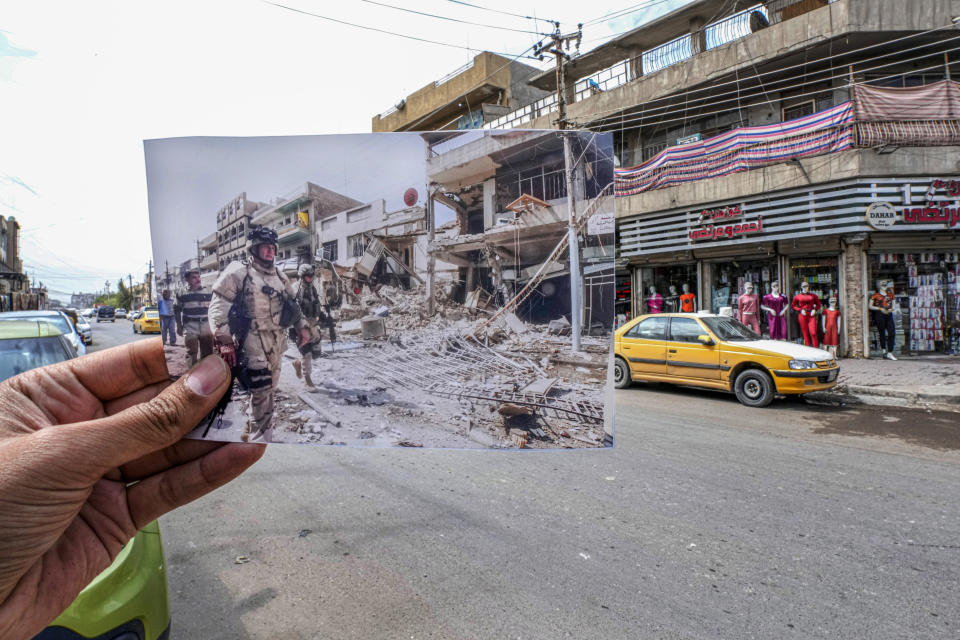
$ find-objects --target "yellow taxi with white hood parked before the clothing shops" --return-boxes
[613,312,840,407]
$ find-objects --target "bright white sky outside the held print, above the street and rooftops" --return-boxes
[0,0,689,301]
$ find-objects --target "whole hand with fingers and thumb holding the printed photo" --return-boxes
[0,340,264,639]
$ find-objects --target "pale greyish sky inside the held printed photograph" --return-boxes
[144,133,425,271]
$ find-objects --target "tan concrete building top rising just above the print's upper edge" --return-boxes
[371,51,549,132]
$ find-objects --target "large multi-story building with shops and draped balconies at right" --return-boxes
[486,0,960,356]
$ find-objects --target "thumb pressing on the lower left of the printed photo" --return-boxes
[67,355,230,469]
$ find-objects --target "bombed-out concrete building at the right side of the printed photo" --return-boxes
[422,131,613,329]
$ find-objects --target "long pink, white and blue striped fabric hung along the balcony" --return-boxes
[614,102,853,196]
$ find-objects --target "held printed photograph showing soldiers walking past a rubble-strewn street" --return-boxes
[146,130,615,449]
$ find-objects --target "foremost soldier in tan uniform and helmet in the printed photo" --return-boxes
[210,227,310,442]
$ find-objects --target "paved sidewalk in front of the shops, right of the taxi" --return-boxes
[811,356,960,410]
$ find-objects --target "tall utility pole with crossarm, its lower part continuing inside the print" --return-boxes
[533,22,583,351]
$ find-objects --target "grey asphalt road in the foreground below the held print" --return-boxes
[144,370,960,640]
